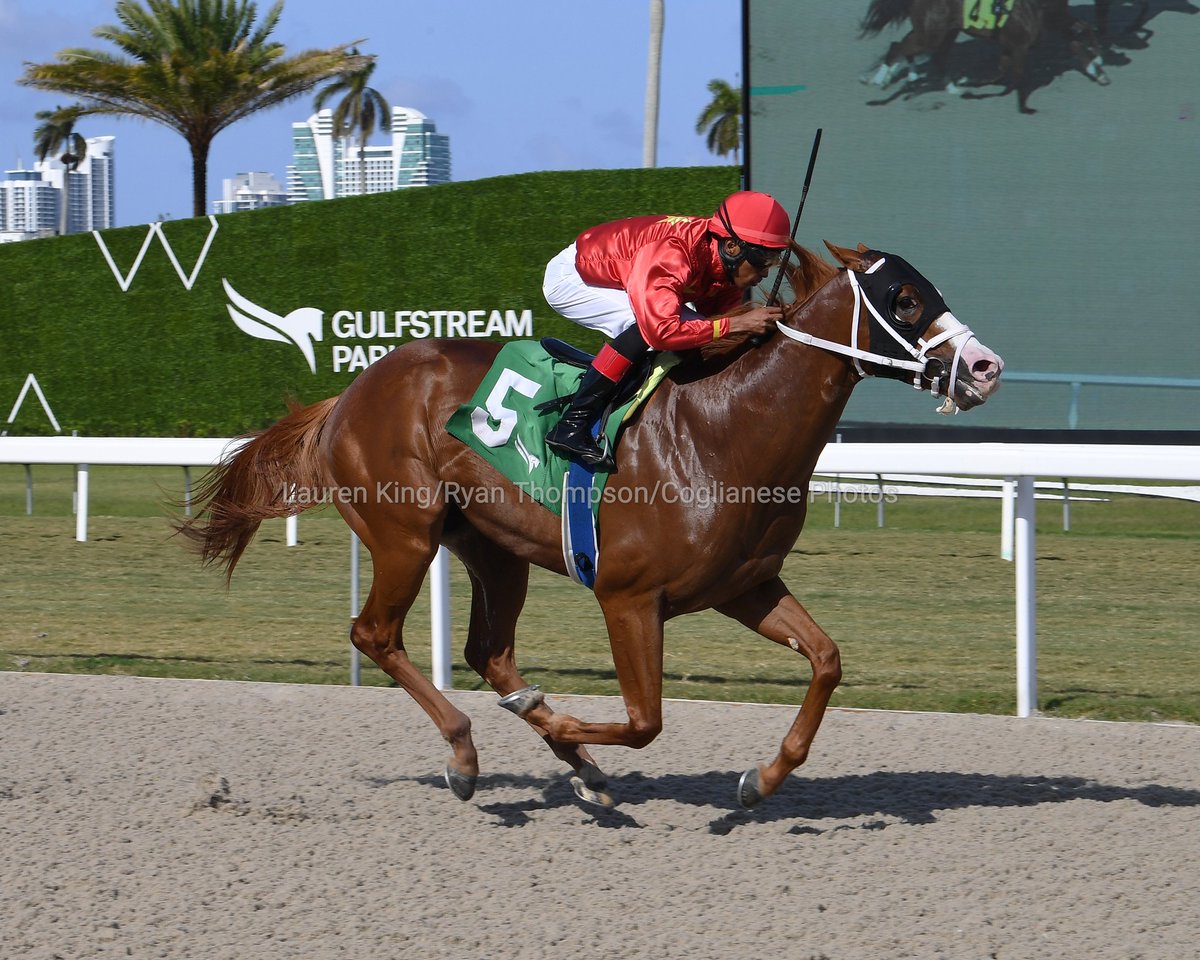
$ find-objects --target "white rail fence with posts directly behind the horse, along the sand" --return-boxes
[0,437,1200,716]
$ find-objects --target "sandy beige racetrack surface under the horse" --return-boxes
[0,673,1200,960]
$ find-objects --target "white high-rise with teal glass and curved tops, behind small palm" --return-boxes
[288,107,450,203]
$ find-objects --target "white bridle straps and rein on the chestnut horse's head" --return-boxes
[775,253,976,414]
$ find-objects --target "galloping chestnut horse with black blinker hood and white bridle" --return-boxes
[179,245,1002,806]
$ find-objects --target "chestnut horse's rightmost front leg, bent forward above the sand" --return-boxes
[716,577,841,806]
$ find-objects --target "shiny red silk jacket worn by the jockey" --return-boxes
[575,216,742,350]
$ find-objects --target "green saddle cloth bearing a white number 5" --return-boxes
[446,340,677,516]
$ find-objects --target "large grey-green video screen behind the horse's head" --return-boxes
[744,0,1200,431]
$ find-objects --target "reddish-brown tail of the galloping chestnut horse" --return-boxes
[173,397,338,581]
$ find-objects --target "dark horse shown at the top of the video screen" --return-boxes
[862,0,1109,113]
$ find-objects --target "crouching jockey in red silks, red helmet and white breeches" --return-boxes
[542,191,790,470]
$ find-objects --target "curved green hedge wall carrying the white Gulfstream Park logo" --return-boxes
[0,167,738,437]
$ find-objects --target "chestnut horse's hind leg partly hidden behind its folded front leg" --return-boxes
[445,524,612,806]
